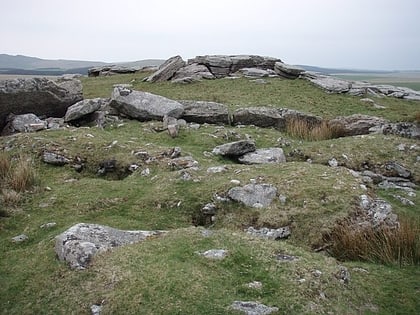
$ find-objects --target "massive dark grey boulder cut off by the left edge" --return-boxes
[0,78,83,130]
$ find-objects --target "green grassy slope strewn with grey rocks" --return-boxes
[0,75,420,314]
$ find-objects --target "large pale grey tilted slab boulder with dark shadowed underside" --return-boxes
[110,86,184,121]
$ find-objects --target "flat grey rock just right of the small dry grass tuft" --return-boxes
[330,114,388,136]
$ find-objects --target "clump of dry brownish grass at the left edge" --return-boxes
[0,152,37,216]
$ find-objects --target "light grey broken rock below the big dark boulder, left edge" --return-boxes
[1,114,47,136]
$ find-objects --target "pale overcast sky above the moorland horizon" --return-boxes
[0,0,420,70]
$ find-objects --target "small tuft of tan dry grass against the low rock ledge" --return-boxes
[286,118,343,141]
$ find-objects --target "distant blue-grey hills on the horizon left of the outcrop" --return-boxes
[0,54,164,75]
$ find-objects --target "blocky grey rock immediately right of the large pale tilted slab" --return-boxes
[179,100,229,125]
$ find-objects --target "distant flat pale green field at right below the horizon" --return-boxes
[334,71,420,91]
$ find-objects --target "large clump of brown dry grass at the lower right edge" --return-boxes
[324,220,420,266]
